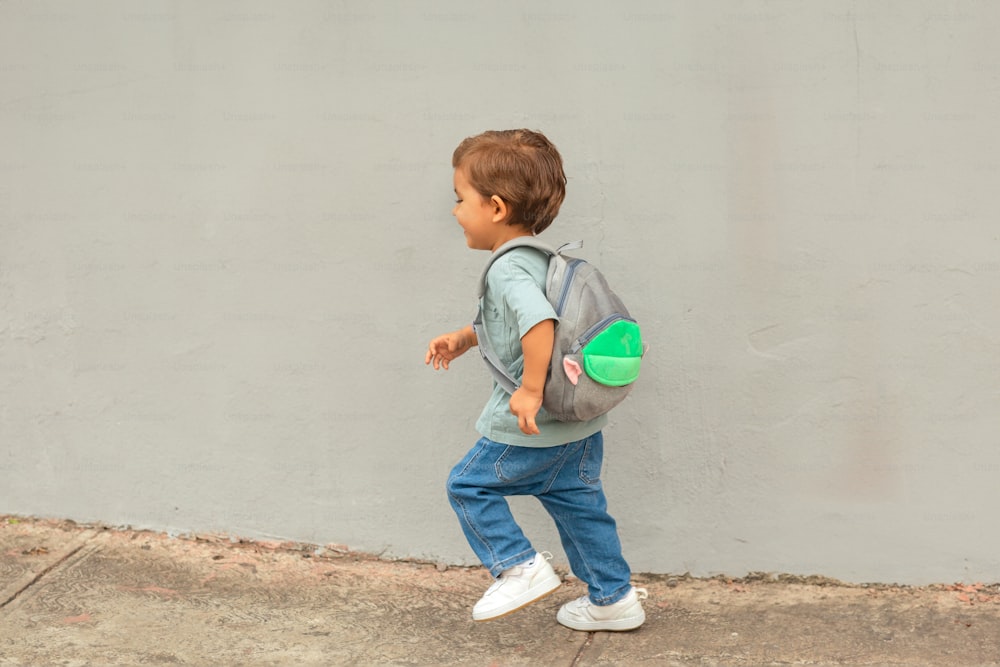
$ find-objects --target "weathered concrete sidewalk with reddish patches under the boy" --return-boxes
[0,517,1000,667]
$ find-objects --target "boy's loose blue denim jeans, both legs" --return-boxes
[448,431,631,605]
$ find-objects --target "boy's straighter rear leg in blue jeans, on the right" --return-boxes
[538,432,632,605]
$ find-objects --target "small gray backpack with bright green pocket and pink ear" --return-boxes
[472,236,646,421]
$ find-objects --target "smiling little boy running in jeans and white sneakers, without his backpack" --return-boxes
[425,130,646,632]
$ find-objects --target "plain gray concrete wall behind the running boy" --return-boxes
[0,0,1000,583]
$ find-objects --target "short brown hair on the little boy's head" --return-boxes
[451,130,566,234]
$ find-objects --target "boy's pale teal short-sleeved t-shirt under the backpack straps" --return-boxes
[476,248,608,447]
